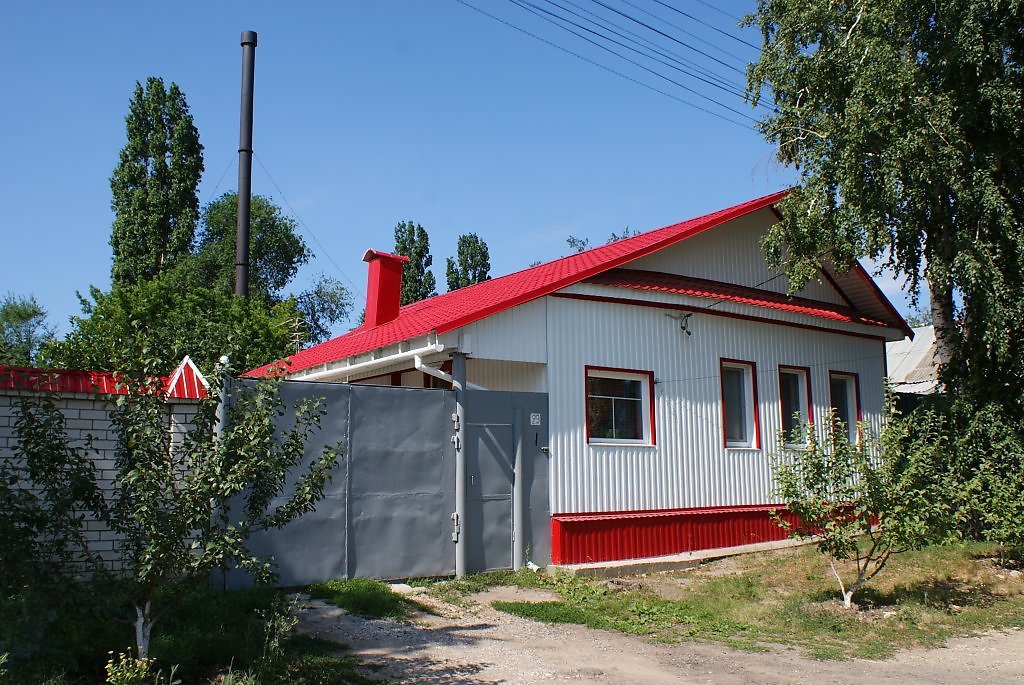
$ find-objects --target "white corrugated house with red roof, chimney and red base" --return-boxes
[252,191,912,563]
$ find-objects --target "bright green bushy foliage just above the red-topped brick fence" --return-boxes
[41,271,302,374]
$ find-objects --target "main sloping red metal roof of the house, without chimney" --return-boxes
[245,190,909,376]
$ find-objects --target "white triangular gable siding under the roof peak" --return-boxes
[626,209,845,304]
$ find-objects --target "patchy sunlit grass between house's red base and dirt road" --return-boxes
[483,544,1024,659]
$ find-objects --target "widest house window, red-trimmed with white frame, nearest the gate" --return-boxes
[587,367,654,444]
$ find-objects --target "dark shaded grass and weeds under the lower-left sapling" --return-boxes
[0,584,372,685]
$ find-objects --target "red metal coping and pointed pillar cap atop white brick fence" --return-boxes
[0,356,209,399]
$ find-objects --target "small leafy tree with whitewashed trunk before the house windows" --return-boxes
[773,415,954,608]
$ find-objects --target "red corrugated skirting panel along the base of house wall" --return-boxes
[551,505,796,564]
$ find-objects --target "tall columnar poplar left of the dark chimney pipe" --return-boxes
[111,77,203,285]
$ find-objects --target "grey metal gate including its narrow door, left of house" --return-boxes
[227,382,550,586]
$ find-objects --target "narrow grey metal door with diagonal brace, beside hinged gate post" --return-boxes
[463,390,515,572]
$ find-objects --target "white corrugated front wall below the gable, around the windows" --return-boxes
[548,298,885,513]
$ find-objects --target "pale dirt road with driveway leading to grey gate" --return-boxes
[299,588,1024,685]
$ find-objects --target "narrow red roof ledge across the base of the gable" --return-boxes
[587,268,888,326]
